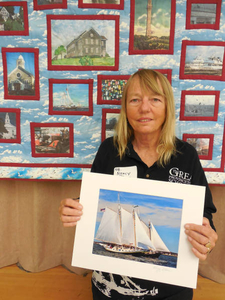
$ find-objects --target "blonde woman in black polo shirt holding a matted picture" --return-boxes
[60,69,217,300]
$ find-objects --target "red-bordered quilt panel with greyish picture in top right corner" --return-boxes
[186,0,222,30]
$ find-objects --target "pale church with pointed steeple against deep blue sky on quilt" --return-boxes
[8,55,35,94]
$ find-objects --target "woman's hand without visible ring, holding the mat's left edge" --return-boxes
[59,198,83,227]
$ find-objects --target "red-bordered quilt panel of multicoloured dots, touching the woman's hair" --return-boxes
[97,75,130,105]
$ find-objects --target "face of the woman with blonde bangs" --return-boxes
[126,76,166,137]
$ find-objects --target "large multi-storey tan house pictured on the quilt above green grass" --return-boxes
[66,28,107,58]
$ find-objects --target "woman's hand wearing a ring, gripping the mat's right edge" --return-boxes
[185,218,218,260]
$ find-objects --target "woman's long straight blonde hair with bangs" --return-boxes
[114,69,176,166]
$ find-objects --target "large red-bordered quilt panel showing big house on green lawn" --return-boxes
[47,15,119,71]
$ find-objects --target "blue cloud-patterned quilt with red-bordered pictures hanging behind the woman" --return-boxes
[0,0,225,184]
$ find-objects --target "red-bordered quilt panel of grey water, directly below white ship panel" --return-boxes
[180,91,220,121]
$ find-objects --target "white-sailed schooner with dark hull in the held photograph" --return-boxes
[95,193,170,257]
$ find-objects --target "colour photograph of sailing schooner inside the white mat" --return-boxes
[93,190,182,266]
